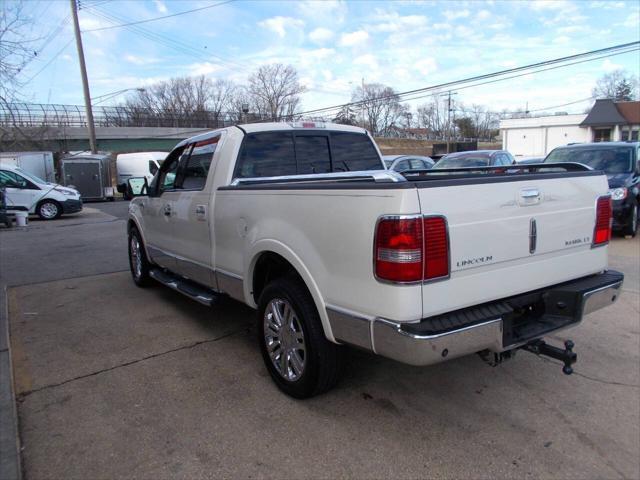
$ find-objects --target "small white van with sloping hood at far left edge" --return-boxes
[0,165,82,220]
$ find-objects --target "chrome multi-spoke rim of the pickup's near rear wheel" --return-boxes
[263,298,307,382]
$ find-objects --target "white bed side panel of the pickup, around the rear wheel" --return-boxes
[214,188,422,339]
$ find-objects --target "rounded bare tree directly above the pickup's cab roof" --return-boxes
[247,63,306,121]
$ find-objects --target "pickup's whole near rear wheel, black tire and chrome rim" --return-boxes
[258,277,343,398]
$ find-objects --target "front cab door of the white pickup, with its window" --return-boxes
[142,145,192,271]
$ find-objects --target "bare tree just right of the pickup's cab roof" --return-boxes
[351,83,404,135]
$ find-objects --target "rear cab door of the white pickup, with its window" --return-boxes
[171,135,221,288]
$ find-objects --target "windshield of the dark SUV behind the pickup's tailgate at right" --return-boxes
[545,147,633,173]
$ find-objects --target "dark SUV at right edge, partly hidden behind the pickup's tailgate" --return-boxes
[544,142,640,236]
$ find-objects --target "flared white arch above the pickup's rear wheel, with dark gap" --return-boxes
[244,246,336,343]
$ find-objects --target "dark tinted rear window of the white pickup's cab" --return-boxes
[234,131,384,178]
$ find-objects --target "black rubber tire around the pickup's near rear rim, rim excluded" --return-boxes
[257,276,344,398]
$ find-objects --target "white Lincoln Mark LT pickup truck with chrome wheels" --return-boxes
[128,122,623,398]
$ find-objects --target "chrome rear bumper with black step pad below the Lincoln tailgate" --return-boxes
[327,271,624,366]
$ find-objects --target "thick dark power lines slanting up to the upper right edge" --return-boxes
[294,41,640,114]
